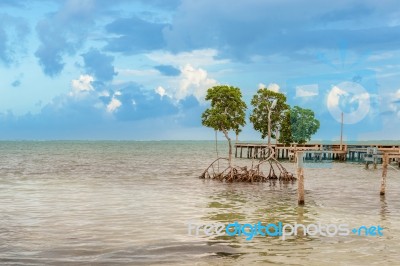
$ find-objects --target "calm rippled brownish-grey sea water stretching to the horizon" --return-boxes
[0,141,400,265]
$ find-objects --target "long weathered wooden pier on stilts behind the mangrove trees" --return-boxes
[235,142,400,167]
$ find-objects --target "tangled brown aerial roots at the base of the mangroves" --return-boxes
[200,150,296,182]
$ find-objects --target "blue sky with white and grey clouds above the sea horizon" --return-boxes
[0,0,400,140]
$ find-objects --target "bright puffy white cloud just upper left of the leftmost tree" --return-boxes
[174,64,218,101]
